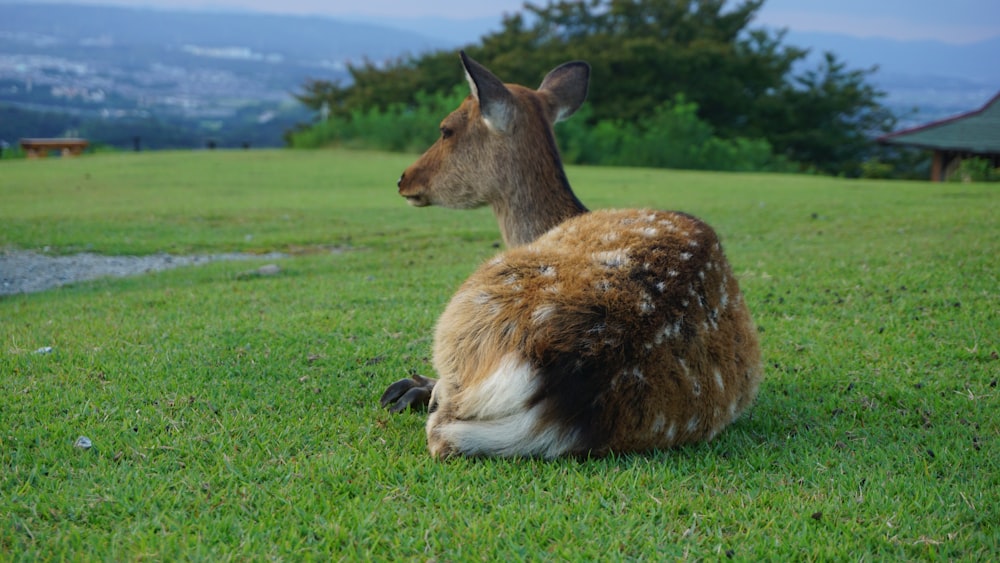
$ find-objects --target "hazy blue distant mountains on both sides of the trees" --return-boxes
[0,0,1000,142]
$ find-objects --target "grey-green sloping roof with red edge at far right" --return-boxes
[878,93,1000,154]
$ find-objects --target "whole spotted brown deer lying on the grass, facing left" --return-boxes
[382,53,762,458]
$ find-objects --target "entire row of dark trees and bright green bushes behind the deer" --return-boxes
[287,0,909,176]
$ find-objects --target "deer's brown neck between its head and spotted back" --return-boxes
[493,143,587,248]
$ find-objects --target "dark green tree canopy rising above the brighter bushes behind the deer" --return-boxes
[292,0,893,175]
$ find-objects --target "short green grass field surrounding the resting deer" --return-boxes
[0,151,1000,561]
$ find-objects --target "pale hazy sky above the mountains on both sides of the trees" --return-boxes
[17,0,1000,43]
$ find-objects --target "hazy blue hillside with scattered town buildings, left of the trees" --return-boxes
[0,3,448,147]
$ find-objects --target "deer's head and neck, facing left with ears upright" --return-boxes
[397,52,590,245]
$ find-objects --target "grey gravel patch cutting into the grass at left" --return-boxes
[0,250,287,295]
